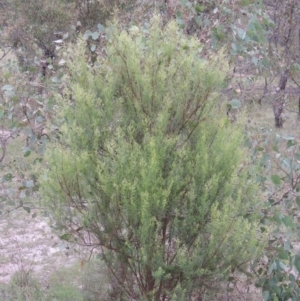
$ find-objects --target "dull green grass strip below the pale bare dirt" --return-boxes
[0,260,109,301]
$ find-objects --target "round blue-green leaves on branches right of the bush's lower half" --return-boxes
[249,129,300,301]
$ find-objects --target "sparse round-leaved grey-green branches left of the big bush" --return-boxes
[0,52,58,215]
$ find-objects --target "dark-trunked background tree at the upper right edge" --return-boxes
[265,0,300,128]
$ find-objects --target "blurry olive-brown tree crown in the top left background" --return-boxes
[6,0,75,67]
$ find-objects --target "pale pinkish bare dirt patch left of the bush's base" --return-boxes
[0,211,79,283]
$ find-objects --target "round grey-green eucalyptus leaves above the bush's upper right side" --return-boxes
[169,0,271,64]
